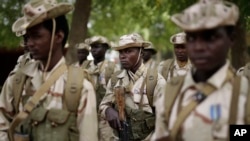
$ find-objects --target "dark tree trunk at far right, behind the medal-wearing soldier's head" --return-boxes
[231,18,249,69]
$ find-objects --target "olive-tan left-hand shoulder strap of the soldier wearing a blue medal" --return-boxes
[165,76,185,124]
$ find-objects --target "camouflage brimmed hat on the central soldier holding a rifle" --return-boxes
[113,33,150,50]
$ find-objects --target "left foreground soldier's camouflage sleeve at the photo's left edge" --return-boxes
[0,75,13,141]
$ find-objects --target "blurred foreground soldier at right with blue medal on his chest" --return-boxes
[152,0,249,141]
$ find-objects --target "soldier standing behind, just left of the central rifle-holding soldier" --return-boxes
[85,36,119,141]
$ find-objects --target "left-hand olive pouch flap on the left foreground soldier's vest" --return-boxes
[30,107,47,122]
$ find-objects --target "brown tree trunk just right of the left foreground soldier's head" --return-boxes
[66,0,91,64]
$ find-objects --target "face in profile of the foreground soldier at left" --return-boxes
[25,24,51,61]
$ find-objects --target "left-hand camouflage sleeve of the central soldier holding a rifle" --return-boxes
[99,80,115,118]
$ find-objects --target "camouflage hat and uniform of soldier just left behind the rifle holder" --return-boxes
[85,36,119,141]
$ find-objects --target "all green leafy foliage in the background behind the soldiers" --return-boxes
[0,0,250,53]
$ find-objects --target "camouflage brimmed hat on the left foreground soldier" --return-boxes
[12,0,73,36]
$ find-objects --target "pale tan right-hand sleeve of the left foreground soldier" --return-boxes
[77,79,98,141]
